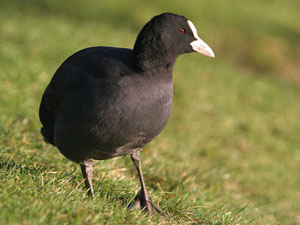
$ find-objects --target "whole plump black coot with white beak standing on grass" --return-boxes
[39,13,214,214]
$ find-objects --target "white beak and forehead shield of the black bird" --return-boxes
[187,20,215,58]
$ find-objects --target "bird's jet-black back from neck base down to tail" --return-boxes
[39,47,134,145]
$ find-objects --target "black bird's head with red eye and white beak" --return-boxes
[134,13,215,67]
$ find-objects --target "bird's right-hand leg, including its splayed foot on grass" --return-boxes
[129,151,165,216]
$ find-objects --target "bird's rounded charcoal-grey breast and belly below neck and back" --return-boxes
[55,74,173,161]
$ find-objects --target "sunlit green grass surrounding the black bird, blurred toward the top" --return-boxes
[0,0,300,225]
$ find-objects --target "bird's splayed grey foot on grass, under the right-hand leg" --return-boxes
[128,193,166,217]
